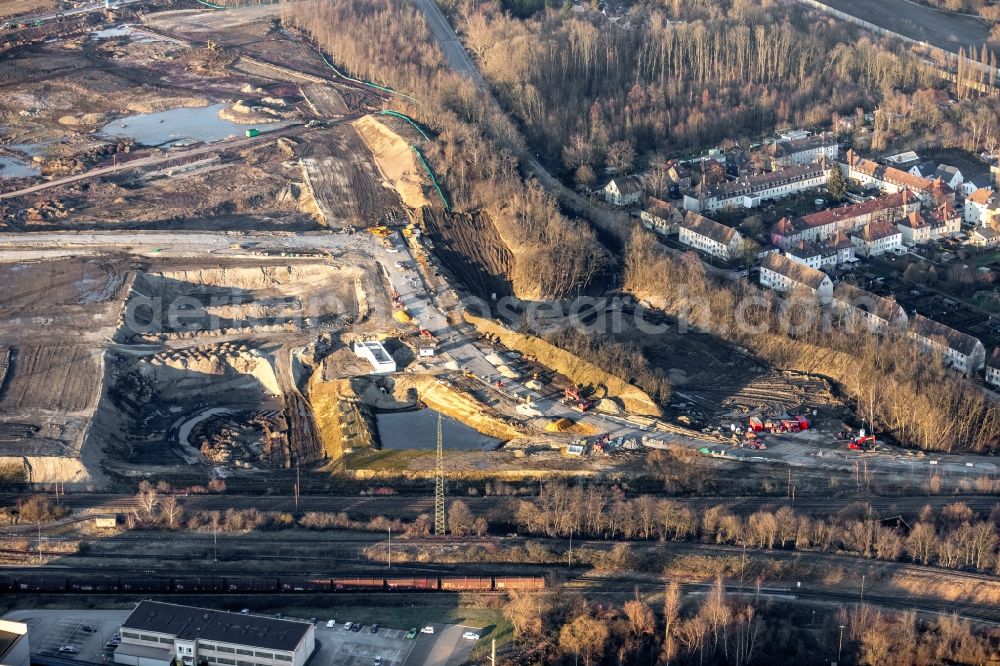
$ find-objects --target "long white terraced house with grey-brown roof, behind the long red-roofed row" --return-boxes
[684,164,830,212]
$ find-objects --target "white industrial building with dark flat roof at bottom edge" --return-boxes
[115,601,316,666]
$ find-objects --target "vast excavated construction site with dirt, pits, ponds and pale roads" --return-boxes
[0,0,860,487]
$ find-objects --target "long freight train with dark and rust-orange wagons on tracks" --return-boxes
[0,573,545,594]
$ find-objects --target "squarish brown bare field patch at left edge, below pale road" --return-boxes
[0,345,101,413]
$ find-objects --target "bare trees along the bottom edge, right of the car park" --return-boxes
[504,579,998,666]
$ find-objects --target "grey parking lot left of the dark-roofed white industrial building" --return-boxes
[5,610,131,664]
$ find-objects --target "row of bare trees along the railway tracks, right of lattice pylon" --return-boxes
[508,483,1000,574]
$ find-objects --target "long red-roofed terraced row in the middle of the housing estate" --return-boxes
[770,190,920,249]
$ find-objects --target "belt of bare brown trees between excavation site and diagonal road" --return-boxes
[282,0,613,299]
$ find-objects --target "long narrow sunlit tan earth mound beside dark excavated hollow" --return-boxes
[465,313,663,418]
